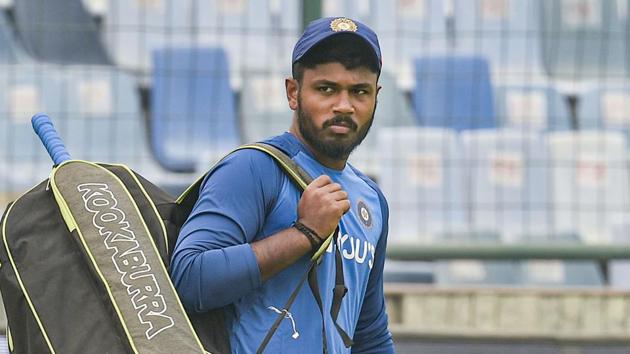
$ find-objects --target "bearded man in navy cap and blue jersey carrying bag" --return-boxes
[171,18,394,353]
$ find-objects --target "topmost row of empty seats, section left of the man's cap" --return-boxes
[0,0,301,79]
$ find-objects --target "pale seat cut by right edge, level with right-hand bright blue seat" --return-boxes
[577,85,630,139]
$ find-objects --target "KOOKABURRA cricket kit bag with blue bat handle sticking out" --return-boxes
[0,115,346,354]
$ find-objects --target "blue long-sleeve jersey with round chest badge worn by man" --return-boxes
[171,133,394,353]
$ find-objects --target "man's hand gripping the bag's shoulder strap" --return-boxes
[298,175,350,240]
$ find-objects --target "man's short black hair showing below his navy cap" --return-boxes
[292,33,380,82]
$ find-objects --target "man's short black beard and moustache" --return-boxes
[297,93,376,160]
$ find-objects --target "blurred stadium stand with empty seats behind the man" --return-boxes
[0,0,630,354]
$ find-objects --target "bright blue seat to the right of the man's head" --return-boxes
[412,56,496,131]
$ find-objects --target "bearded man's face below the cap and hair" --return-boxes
[289,63,378,160]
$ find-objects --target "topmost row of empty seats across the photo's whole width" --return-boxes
[4,0,630,82]
